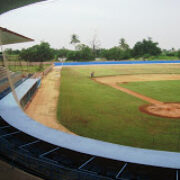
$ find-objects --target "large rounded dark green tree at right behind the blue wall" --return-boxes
[133,38,161,57]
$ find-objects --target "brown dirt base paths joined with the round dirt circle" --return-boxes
[94,74,180,118]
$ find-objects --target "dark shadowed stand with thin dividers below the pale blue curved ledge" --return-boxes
[0,117,178,180]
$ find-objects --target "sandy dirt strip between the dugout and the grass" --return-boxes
[25,67,73,134]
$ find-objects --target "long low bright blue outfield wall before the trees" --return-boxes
[54,60,180,66]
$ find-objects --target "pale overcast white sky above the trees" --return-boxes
[0,0,180,49]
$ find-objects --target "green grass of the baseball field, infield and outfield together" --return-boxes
[57,64,180,152]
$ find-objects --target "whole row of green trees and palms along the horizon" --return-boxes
[6,34,180,62]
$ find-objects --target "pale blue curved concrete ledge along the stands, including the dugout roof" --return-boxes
[0,79,180,169]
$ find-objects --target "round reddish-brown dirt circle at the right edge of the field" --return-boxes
[139,103,180,118]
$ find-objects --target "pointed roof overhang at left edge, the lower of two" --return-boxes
[0,27,34,45]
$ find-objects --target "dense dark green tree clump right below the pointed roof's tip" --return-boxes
[20,42,54,62]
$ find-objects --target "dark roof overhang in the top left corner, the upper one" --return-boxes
[0,0,45,15]
